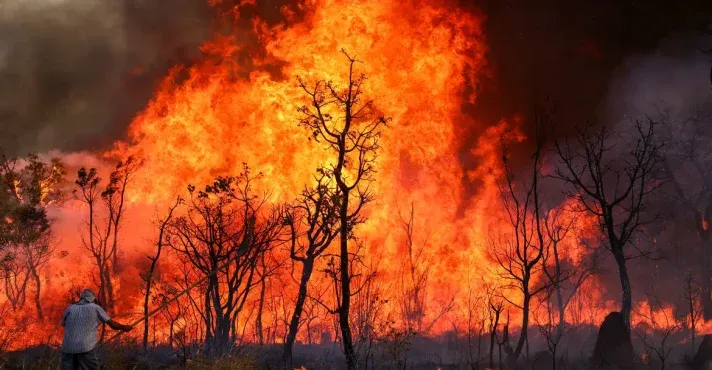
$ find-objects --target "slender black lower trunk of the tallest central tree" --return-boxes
[339,189,356,370]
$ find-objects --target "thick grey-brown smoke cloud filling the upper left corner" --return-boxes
[0,0,213,154]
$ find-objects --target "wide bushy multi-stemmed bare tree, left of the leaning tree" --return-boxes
[167,165,283,355]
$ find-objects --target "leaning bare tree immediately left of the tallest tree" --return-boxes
[283,169,339,364]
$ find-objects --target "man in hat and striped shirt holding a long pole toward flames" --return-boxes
[60,289,132,370]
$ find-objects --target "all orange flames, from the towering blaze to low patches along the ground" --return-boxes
[0,0,708,358]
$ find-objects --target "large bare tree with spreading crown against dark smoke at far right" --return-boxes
[555,121,662,330]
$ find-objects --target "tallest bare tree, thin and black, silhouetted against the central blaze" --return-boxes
[299,52,388,370]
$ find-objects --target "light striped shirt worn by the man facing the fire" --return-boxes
[62,300,110,353]
